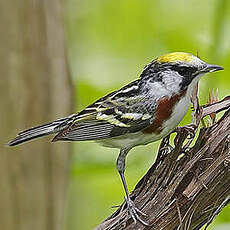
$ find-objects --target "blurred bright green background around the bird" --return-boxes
[65,0,230,230]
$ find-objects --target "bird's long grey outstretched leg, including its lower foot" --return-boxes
[116,149,149,226]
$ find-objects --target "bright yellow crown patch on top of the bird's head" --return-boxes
[156,52,194,63]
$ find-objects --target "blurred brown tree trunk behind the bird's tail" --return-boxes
[0,0,72,230]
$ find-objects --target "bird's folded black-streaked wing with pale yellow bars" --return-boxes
[53,81,156,141]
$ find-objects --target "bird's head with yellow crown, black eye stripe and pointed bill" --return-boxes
[141,52,224,88]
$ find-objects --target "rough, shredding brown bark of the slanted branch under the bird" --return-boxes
[96,93,230,230]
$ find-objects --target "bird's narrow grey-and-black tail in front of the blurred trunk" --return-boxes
[8,114,74,146]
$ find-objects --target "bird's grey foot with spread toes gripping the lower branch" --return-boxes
[125,197,149,226]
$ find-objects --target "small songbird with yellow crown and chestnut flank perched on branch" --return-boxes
[8,52,224,225]
